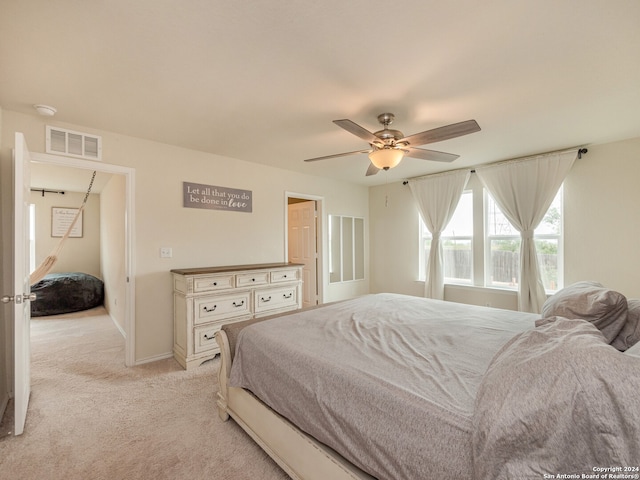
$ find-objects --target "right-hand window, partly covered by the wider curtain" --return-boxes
[485,189,563,292]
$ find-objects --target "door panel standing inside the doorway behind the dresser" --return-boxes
[288,200,318,307]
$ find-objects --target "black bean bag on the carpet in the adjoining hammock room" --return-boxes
[31,272,104,317]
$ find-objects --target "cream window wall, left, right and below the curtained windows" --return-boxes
[369,138,640,309]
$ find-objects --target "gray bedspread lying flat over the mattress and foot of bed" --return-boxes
[230,294,539,479]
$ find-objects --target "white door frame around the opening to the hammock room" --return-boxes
[31,153,136,367]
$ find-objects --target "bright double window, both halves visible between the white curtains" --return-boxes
[419,182,564,293]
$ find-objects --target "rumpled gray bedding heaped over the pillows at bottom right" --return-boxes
[473,317,640,480]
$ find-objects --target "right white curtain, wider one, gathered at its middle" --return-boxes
[476,150,578,313]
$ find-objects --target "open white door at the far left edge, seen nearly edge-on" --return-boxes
[13,132,31,435]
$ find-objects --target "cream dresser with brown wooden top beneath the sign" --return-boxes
[171,263,302,369]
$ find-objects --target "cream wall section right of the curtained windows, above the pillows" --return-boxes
[565,138,640,298]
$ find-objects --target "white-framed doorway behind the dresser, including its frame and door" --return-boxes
[285,193,323,307]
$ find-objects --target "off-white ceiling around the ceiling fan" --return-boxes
[0,0,640,185]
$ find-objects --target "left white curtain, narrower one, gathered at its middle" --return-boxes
[409,170,470,300]
